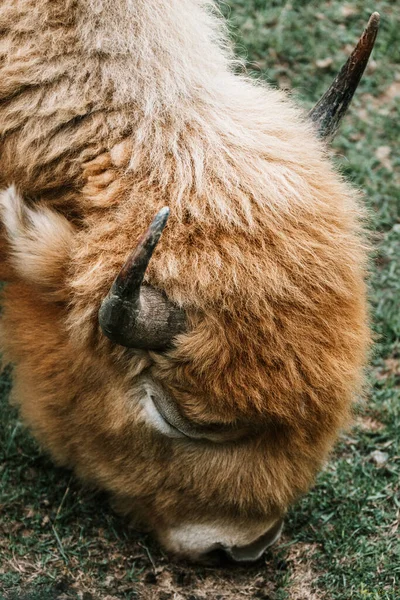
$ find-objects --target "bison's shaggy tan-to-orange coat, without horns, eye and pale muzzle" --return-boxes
[0,0,369,556]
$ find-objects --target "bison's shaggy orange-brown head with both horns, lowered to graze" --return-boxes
[0,11,377,561]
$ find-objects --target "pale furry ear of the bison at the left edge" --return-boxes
[0,186,74,299]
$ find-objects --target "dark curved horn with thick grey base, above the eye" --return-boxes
[99,207,185,350]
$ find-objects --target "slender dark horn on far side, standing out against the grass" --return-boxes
[309,12,380,140]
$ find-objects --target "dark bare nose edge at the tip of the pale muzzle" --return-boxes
[201,519,283,565]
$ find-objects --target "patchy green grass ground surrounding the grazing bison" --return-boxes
[0,0,400,600]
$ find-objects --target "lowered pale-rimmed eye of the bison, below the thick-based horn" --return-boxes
[142,381,248,443]
